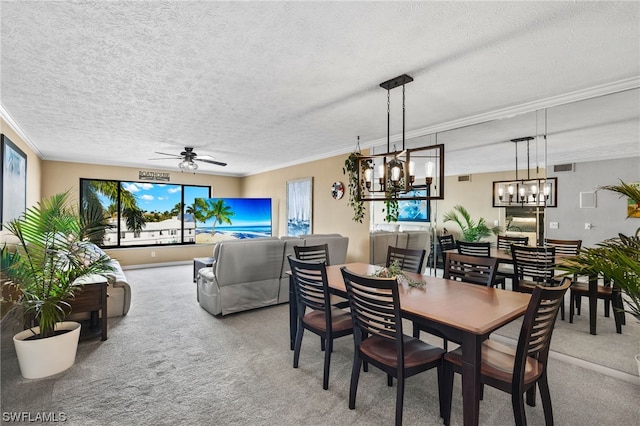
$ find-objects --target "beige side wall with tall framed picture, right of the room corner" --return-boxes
[242,150,369,262]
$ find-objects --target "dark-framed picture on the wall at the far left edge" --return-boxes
[0,135,27,228]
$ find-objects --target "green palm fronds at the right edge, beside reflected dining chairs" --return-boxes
[558,180,640,321]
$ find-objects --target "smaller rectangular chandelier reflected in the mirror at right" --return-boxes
[493,136,558,207]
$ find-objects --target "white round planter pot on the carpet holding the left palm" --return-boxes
[13,321,80,379]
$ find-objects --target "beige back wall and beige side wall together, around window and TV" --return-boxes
[42,156,369,266]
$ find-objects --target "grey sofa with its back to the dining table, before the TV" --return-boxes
[197,234,349,315]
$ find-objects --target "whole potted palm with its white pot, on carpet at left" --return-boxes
[5,191,113,378]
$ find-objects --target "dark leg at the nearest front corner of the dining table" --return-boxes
[462,333,482,426]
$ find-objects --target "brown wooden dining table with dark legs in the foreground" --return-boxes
[289,263,531,426]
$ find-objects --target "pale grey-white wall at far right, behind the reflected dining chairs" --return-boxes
[545,157,640,247]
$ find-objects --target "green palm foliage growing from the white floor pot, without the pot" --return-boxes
[5,191,113,337]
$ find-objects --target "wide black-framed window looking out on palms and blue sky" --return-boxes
[80,179,211,247]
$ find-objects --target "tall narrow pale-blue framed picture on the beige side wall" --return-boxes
[287,178,313,237]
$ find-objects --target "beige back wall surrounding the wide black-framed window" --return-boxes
[42,161,242,266]
